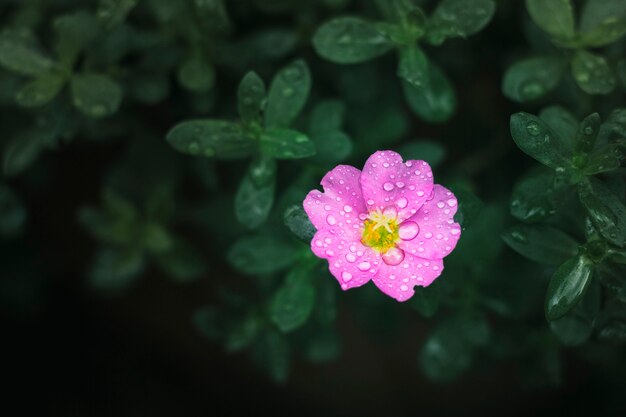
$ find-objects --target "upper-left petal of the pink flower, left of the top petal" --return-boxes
[304,165,367,238]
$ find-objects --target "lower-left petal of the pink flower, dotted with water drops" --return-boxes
[311,229,382,290]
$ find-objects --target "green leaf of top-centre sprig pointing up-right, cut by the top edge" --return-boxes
[427,0,496,45]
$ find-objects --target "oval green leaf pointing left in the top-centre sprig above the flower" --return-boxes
[313,17,393,64]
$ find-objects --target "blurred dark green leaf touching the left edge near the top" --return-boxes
[0,32,56,77]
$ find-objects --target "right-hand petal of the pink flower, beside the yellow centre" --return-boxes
[398,184,461,259]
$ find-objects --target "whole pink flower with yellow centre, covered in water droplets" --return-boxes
[304,151,461,301]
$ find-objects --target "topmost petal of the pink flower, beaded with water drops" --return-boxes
[361,151,433,221]
